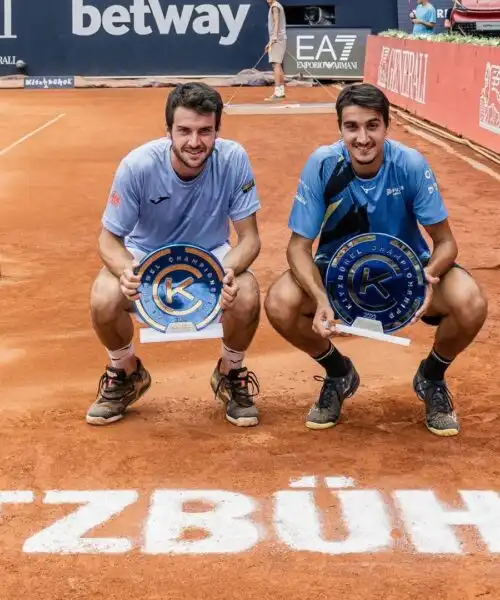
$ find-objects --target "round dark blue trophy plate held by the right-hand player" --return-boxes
[325,233,426,333]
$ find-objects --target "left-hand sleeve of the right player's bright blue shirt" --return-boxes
[288,153,325,240]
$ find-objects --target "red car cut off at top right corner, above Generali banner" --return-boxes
[450,0,500,37]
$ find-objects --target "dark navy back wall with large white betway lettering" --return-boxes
[0,0,398,76]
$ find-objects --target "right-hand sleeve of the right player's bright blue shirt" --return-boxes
[408,152,448,225]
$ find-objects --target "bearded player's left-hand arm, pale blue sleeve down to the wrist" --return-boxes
[98,156,140,277]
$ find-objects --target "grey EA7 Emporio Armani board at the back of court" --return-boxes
[283,27,370,79]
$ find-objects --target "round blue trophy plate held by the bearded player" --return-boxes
[135,244,224,333]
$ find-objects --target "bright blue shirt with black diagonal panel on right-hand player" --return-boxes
[289,140,448,263]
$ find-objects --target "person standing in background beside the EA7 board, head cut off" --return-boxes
[265,0,286,102]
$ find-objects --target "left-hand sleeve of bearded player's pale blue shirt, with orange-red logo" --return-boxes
[102,160,140,237]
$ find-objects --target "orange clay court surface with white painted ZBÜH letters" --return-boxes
[0,88,500,600]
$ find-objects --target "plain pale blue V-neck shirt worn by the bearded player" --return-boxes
[102,137,260,252]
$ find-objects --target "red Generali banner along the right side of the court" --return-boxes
[364,35,500,153]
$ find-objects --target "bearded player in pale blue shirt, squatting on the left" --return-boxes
[87,83,260,427]
